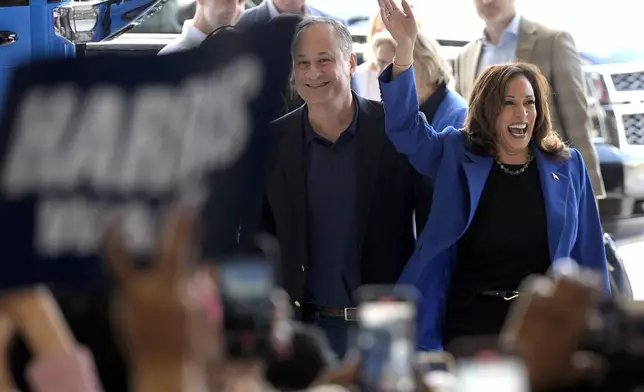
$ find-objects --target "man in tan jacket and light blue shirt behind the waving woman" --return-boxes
[454,0,606,198]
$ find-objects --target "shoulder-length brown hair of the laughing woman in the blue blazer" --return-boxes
[464,63,570,159]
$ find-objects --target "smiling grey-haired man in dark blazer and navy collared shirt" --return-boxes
[255,17,430,357]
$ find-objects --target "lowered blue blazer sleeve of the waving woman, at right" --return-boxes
[571,149,610,293]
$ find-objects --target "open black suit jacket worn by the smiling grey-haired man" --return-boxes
[261,96,430,317]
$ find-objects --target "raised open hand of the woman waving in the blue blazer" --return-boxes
[378,0,418,52]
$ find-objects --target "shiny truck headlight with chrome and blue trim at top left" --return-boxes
[53,0,168,44]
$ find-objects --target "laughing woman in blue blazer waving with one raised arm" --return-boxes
[379,0,610,350]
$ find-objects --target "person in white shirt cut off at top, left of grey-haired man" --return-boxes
[159,0,244,55]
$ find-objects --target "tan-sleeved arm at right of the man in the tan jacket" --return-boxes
[552,32,606,199]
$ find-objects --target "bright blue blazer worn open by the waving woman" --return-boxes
[380,66,610,350]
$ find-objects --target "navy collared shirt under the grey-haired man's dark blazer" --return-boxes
[304,100,360,308]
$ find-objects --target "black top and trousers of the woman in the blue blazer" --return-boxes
[443,161,551,343]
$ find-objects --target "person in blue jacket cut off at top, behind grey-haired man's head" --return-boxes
[238,0,346,28]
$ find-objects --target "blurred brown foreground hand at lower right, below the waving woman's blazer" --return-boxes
[501,271,601,391]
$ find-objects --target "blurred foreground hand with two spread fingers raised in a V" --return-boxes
[106,210,196,369]
